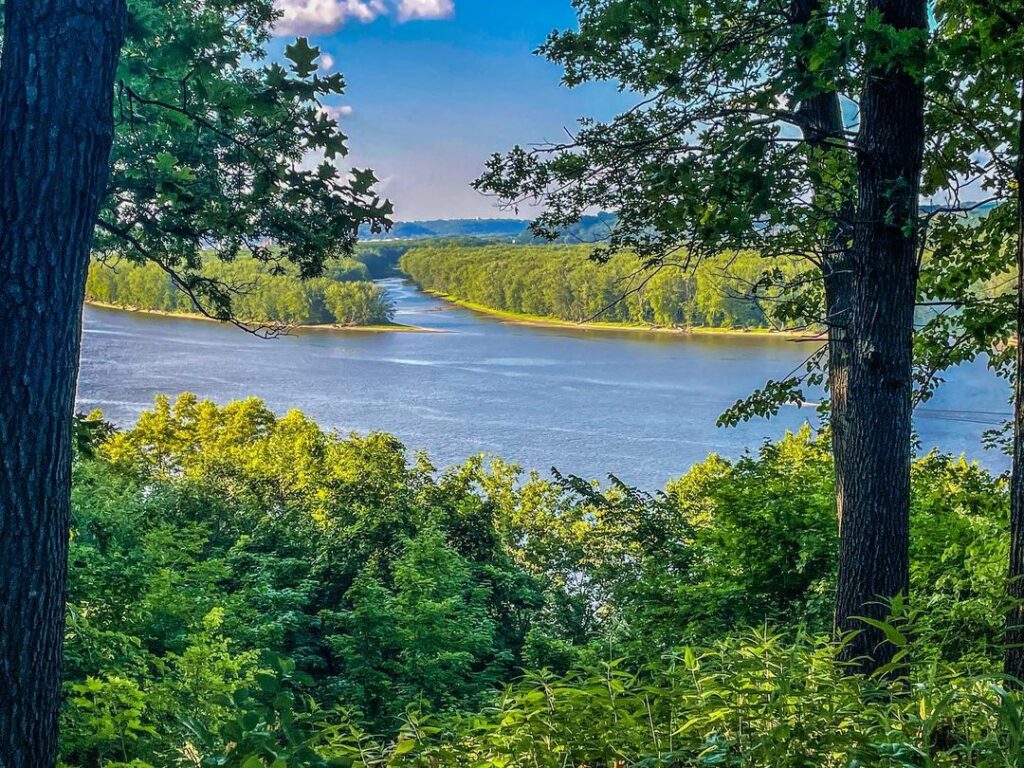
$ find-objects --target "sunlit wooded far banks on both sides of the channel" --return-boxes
[86,242,823,343]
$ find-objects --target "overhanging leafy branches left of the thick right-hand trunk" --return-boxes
[476,0,864,290]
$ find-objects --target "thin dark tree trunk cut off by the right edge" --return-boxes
[1004,66,1024,681]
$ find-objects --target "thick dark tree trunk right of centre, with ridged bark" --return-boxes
[836,0,928,672]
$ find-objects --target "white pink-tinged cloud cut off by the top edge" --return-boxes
[274,0,455,35]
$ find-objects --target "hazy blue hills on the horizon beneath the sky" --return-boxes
[359,213,615,243]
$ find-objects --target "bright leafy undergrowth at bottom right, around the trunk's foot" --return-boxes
[380,620,1024,768]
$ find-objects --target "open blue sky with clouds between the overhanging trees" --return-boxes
[271,0,628,220]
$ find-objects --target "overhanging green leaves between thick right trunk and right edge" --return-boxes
[915,0,1024,396]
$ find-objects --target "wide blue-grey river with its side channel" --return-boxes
[78,279,1010,488]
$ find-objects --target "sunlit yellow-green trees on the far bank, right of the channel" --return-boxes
[401,245,782,328]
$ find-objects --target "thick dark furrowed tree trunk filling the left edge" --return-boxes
[0,0,124,768]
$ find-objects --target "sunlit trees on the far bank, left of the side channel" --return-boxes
[85,258,394,326]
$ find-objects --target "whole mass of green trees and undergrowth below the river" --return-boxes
[61,395,1020,768]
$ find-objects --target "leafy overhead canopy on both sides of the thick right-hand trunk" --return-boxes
[476,0,1024,421]
